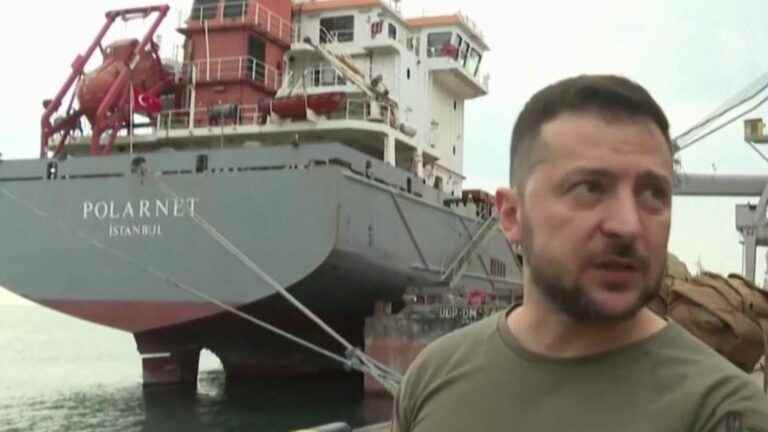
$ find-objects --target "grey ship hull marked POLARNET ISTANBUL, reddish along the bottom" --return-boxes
[0,144,519,384]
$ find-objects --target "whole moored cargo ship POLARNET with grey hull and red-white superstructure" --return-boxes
[0,0,522,387]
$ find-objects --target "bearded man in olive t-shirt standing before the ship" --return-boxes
[393,76,768,432]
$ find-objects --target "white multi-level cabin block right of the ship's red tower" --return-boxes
[286,0,488,196]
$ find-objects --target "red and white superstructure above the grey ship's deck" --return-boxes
[51,0,488,197]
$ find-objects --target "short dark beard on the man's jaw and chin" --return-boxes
[521,215,664,323]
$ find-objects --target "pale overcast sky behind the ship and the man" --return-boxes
[0,0,768,302]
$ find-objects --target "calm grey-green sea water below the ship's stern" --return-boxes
[0,305,390,432]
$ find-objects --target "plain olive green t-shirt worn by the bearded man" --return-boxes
[392,313,768,432]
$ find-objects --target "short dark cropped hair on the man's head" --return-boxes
[510,75,672,186]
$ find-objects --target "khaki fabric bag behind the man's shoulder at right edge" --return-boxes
[651,255,768,372]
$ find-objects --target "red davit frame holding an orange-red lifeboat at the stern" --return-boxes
[40,5,174,159]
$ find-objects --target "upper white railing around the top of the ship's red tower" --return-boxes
[189,0,292,44]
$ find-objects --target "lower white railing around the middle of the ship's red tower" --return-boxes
[181,56,281,90]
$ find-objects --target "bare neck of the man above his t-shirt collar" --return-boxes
[507,296,666,358]
